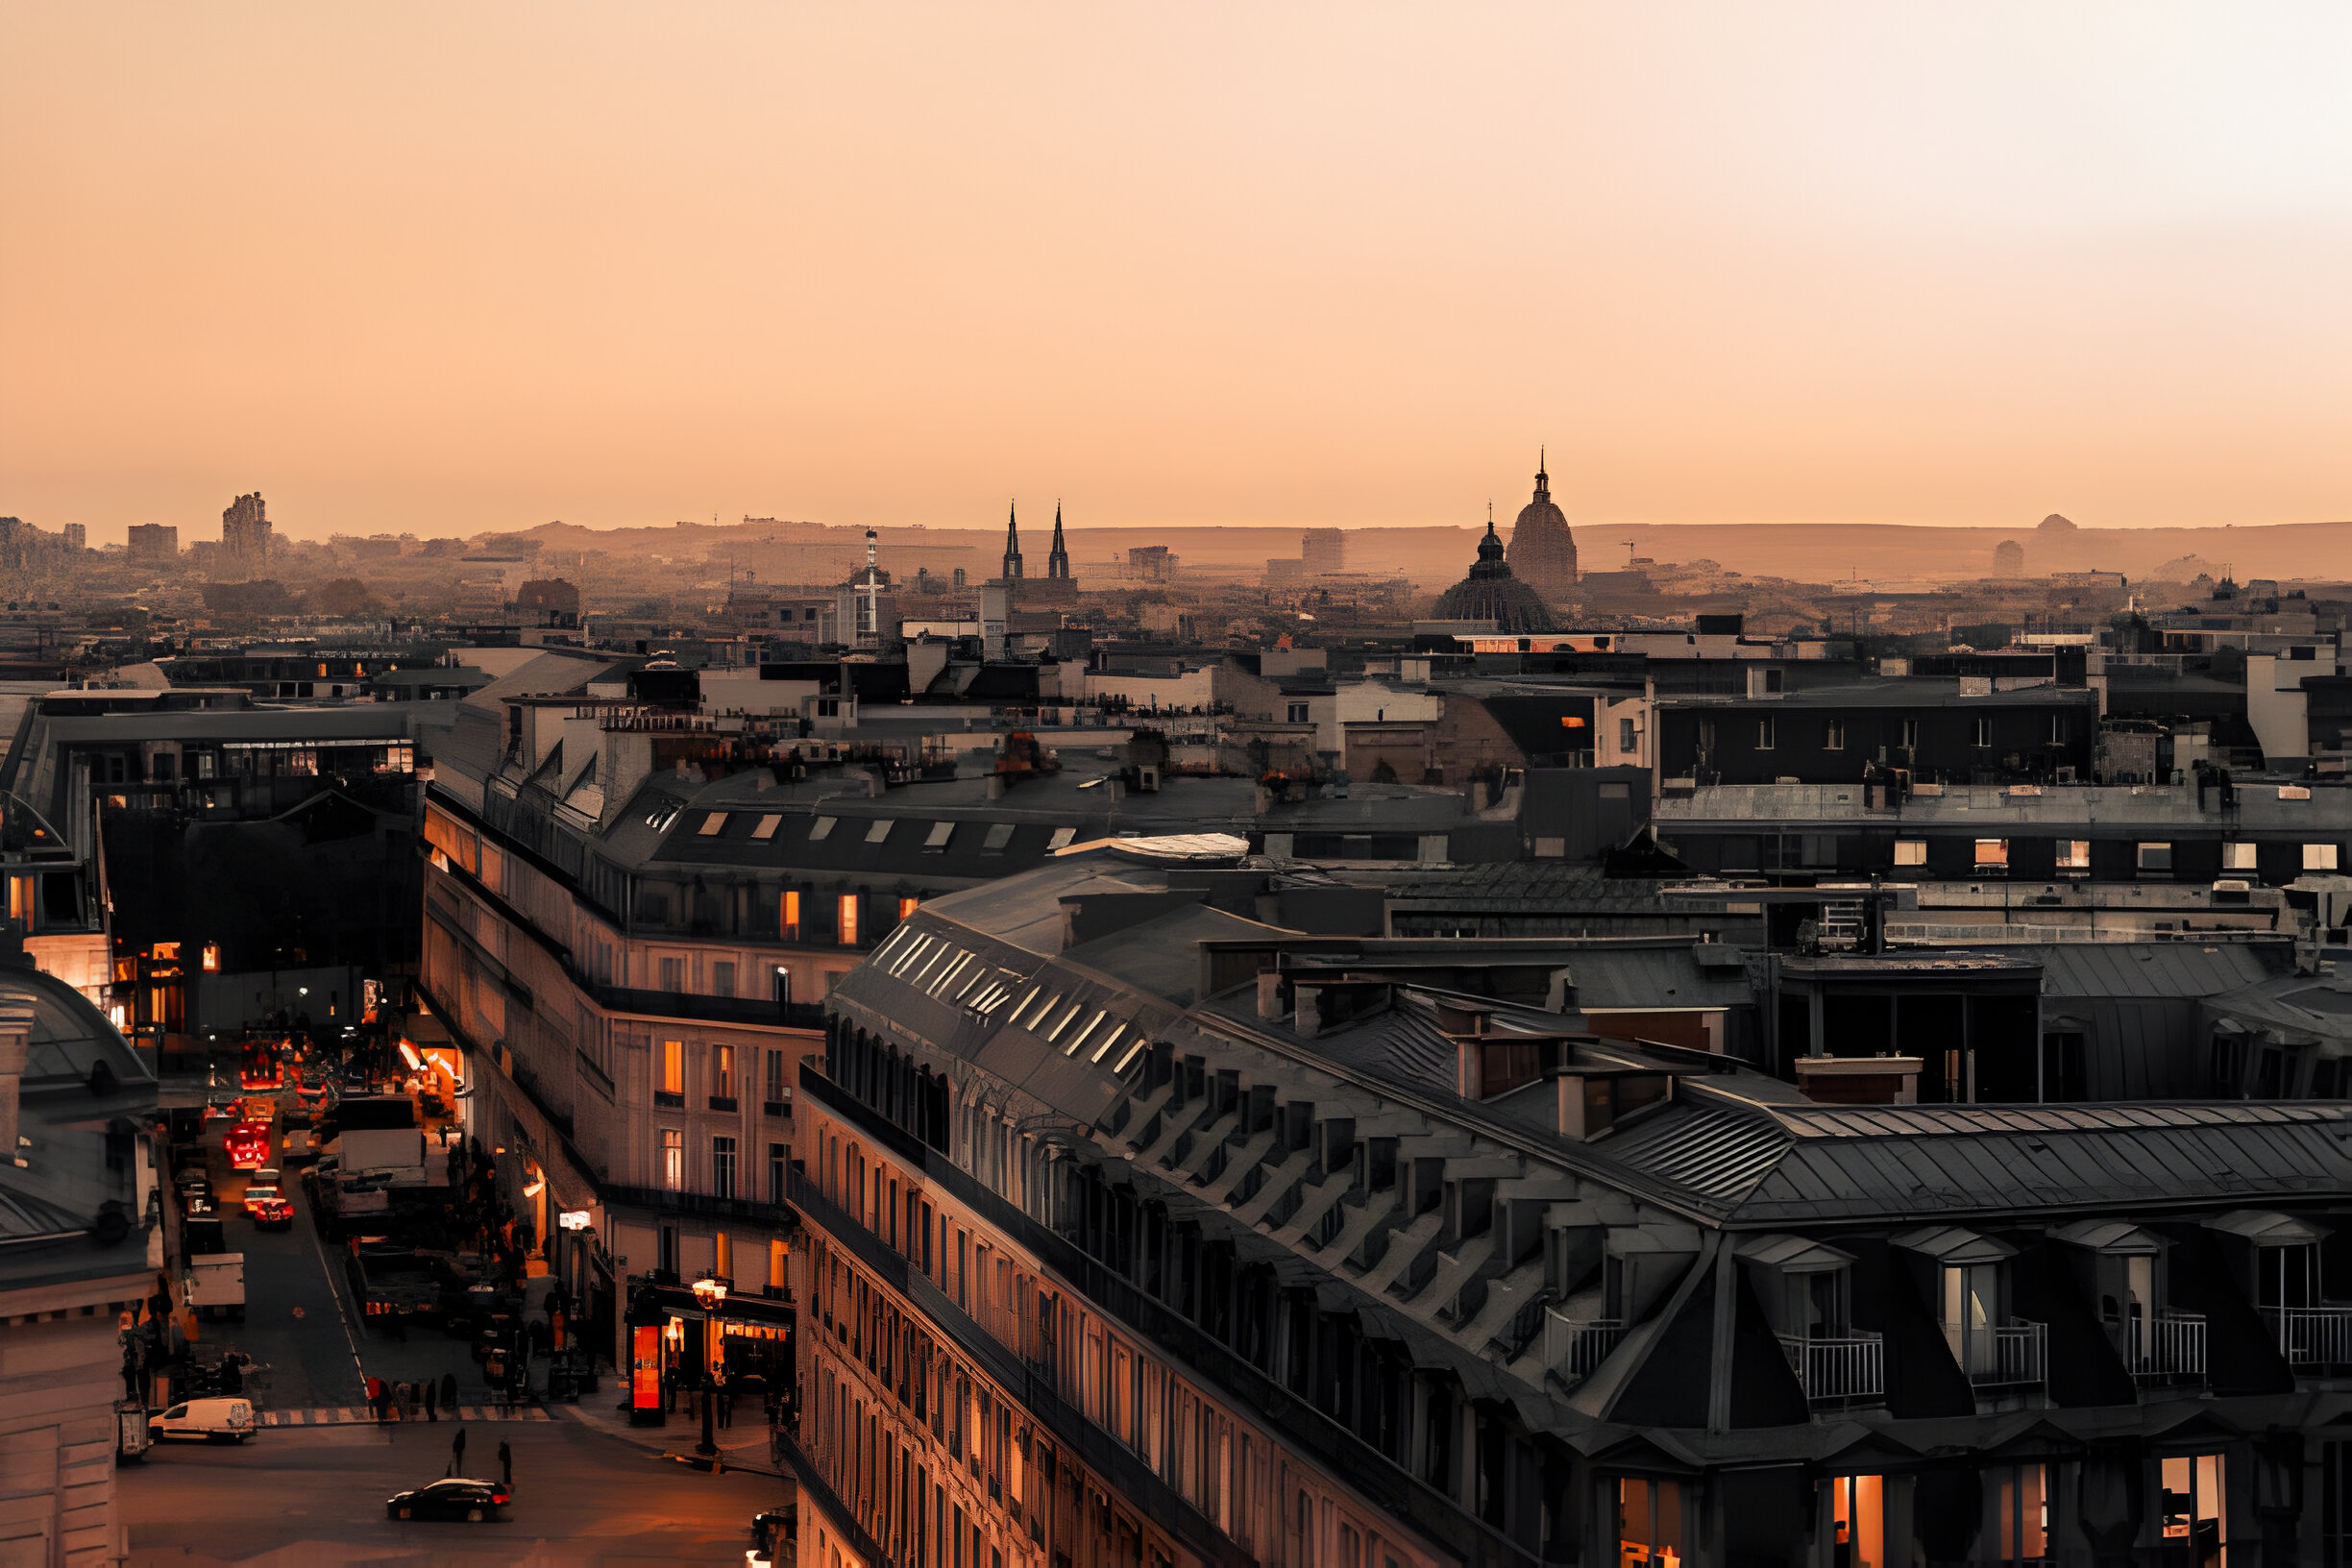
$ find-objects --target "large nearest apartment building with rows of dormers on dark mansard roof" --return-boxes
[788,842,2352,1568]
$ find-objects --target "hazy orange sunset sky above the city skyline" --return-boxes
[0,0,2352,543]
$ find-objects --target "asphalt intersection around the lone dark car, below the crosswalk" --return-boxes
[117,1413,786,1568]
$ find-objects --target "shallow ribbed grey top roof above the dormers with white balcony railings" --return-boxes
[1587,1086,2352,1227]
